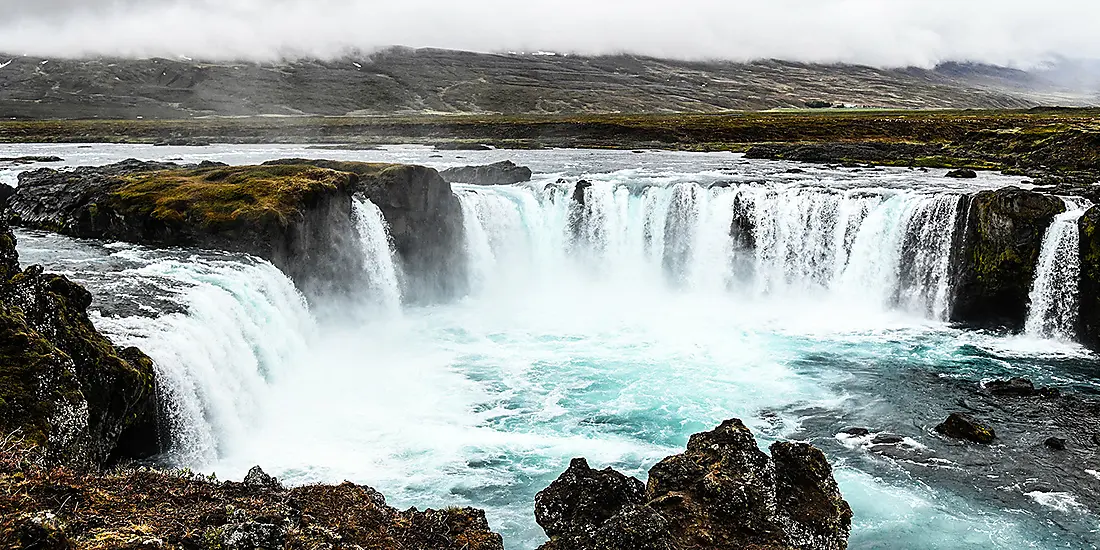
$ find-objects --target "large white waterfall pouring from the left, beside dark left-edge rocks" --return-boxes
[96,257,316,464]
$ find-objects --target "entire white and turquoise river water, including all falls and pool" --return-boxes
[0,145,1100,549]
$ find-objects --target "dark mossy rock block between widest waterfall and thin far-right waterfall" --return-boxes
[952,187,1066,330]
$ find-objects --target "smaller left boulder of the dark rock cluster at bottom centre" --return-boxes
[535,459,646,548]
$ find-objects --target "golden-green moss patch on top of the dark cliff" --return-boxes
[111,165,349,230]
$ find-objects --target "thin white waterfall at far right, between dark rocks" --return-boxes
[1024,198,1089,340]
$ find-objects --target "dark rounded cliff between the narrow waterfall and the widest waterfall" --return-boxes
[268,158,466,303]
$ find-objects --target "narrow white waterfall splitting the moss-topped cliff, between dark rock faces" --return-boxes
[352,197,402,311]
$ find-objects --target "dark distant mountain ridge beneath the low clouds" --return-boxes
[0,48,1100,119]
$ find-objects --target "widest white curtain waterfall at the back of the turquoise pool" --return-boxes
[459,183,961,320]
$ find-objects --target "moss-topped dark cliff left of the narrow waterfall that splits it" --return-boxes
[8,161,361,296]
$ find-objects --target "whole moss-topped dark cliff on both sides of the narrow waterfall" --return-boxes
[7,160,462,299]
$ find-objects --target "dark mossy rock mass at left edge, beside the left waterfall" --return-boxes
[0,216,160,465]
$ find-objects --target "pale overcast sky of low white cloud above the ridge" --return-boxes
[0,0,1100,67]
